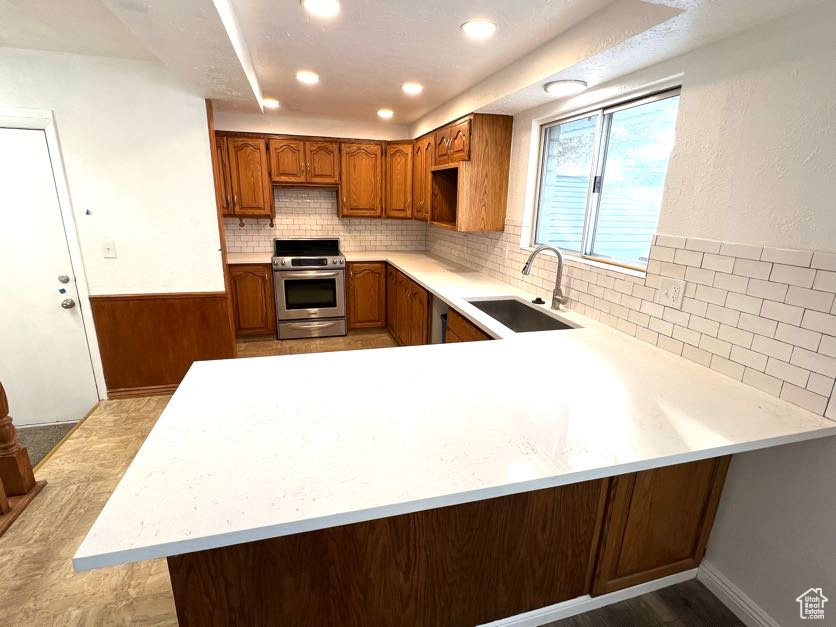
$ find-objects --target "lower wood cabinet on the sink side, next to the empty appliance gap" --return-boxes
[386,266,430,346]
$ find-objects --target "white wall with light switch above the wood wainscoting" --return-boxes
[0,48,224,294]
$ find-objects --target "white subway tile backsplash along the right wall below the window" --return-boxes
[428,224,836,420]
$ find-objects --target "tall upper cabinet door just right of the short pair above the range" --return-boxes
[340,143,383,218]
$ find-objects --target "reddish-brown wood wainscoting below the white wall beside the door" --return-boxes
[90,292,235,398]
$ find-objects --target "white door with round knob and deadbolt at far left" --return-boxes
[0,128,98,426]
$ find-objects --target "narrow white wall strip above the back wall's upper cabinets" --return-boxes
[215,109,411,140]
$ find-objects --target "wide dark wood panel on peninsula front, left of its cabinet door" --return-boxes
[168,480,607,627]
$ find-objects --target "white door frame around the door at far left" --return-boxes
[0,107,107,402]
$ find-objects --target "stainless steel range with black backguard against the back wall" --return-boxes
[273,239,346,340]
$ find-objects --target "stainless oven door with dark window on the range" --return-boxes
[273,270,345,320]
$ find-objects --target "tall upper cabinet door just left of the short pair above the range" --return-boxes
[226,137,273,217]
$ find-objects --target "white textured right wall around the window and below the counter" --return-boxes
[496,3,836,625]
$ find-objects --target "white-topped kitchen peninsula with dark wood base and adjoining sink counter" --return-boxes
[74,253,836,625]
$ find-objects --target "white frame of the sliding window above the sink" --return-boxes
[528,85,682,274]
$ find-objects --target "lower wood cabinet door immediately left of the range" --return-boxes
[229,264,276,336]
